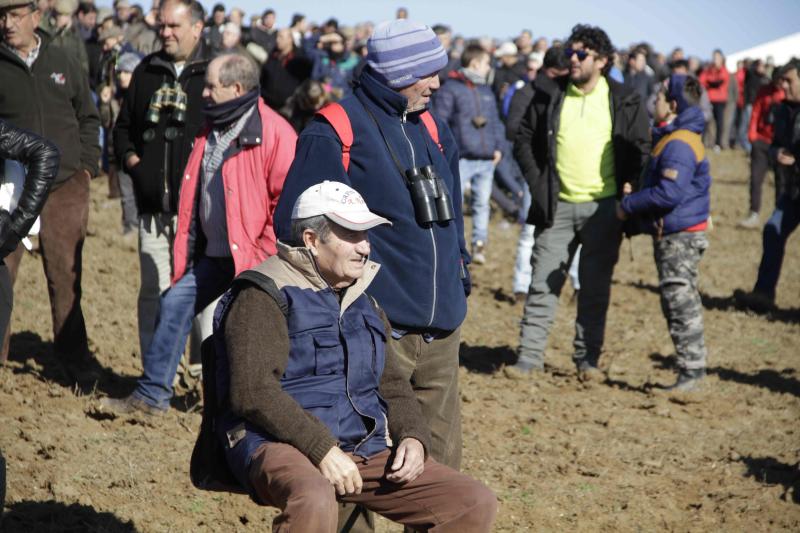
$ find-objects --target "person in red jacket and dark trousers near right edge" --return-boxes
[739,68,784,229]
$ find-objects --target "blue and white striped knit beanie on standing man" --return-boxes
[367,19,447,89]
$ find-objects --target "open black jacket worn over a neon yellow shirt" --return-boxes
[514,77,650,228]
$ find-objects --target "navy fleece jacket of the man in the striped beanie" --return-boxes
[275,67,469,331]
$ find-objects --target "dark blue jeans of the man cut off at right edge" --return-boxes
[754,194,800,298]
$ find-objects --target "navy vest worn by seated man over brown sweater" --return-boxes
[214,278,388,487]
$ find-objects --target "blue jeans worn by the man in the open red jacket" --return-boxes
[133,256,234,409]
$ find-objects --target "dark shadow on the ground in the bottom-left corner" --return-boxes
[0,501,137,533]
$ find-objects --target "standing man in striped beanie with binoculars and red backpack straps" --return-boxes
[275,20,470,469]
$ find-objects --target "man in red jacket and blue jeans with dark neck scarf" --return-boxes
[101,54,297,414]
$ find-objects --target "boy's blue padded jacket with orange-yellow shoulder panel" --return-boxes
[622,106,711,235]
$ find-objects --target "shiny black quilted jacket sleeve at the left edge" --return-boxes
[0,120,59,257]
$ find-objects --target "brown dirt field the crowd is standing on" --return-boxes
[0,149,800,532]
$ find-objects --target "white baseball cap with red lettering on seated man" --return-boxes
[292,180,392,231]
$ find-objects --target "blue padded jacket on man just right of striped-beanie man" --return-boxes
[433,72,505,159]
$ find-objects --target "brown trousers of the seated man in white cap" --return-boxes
[250,442,497,533]
